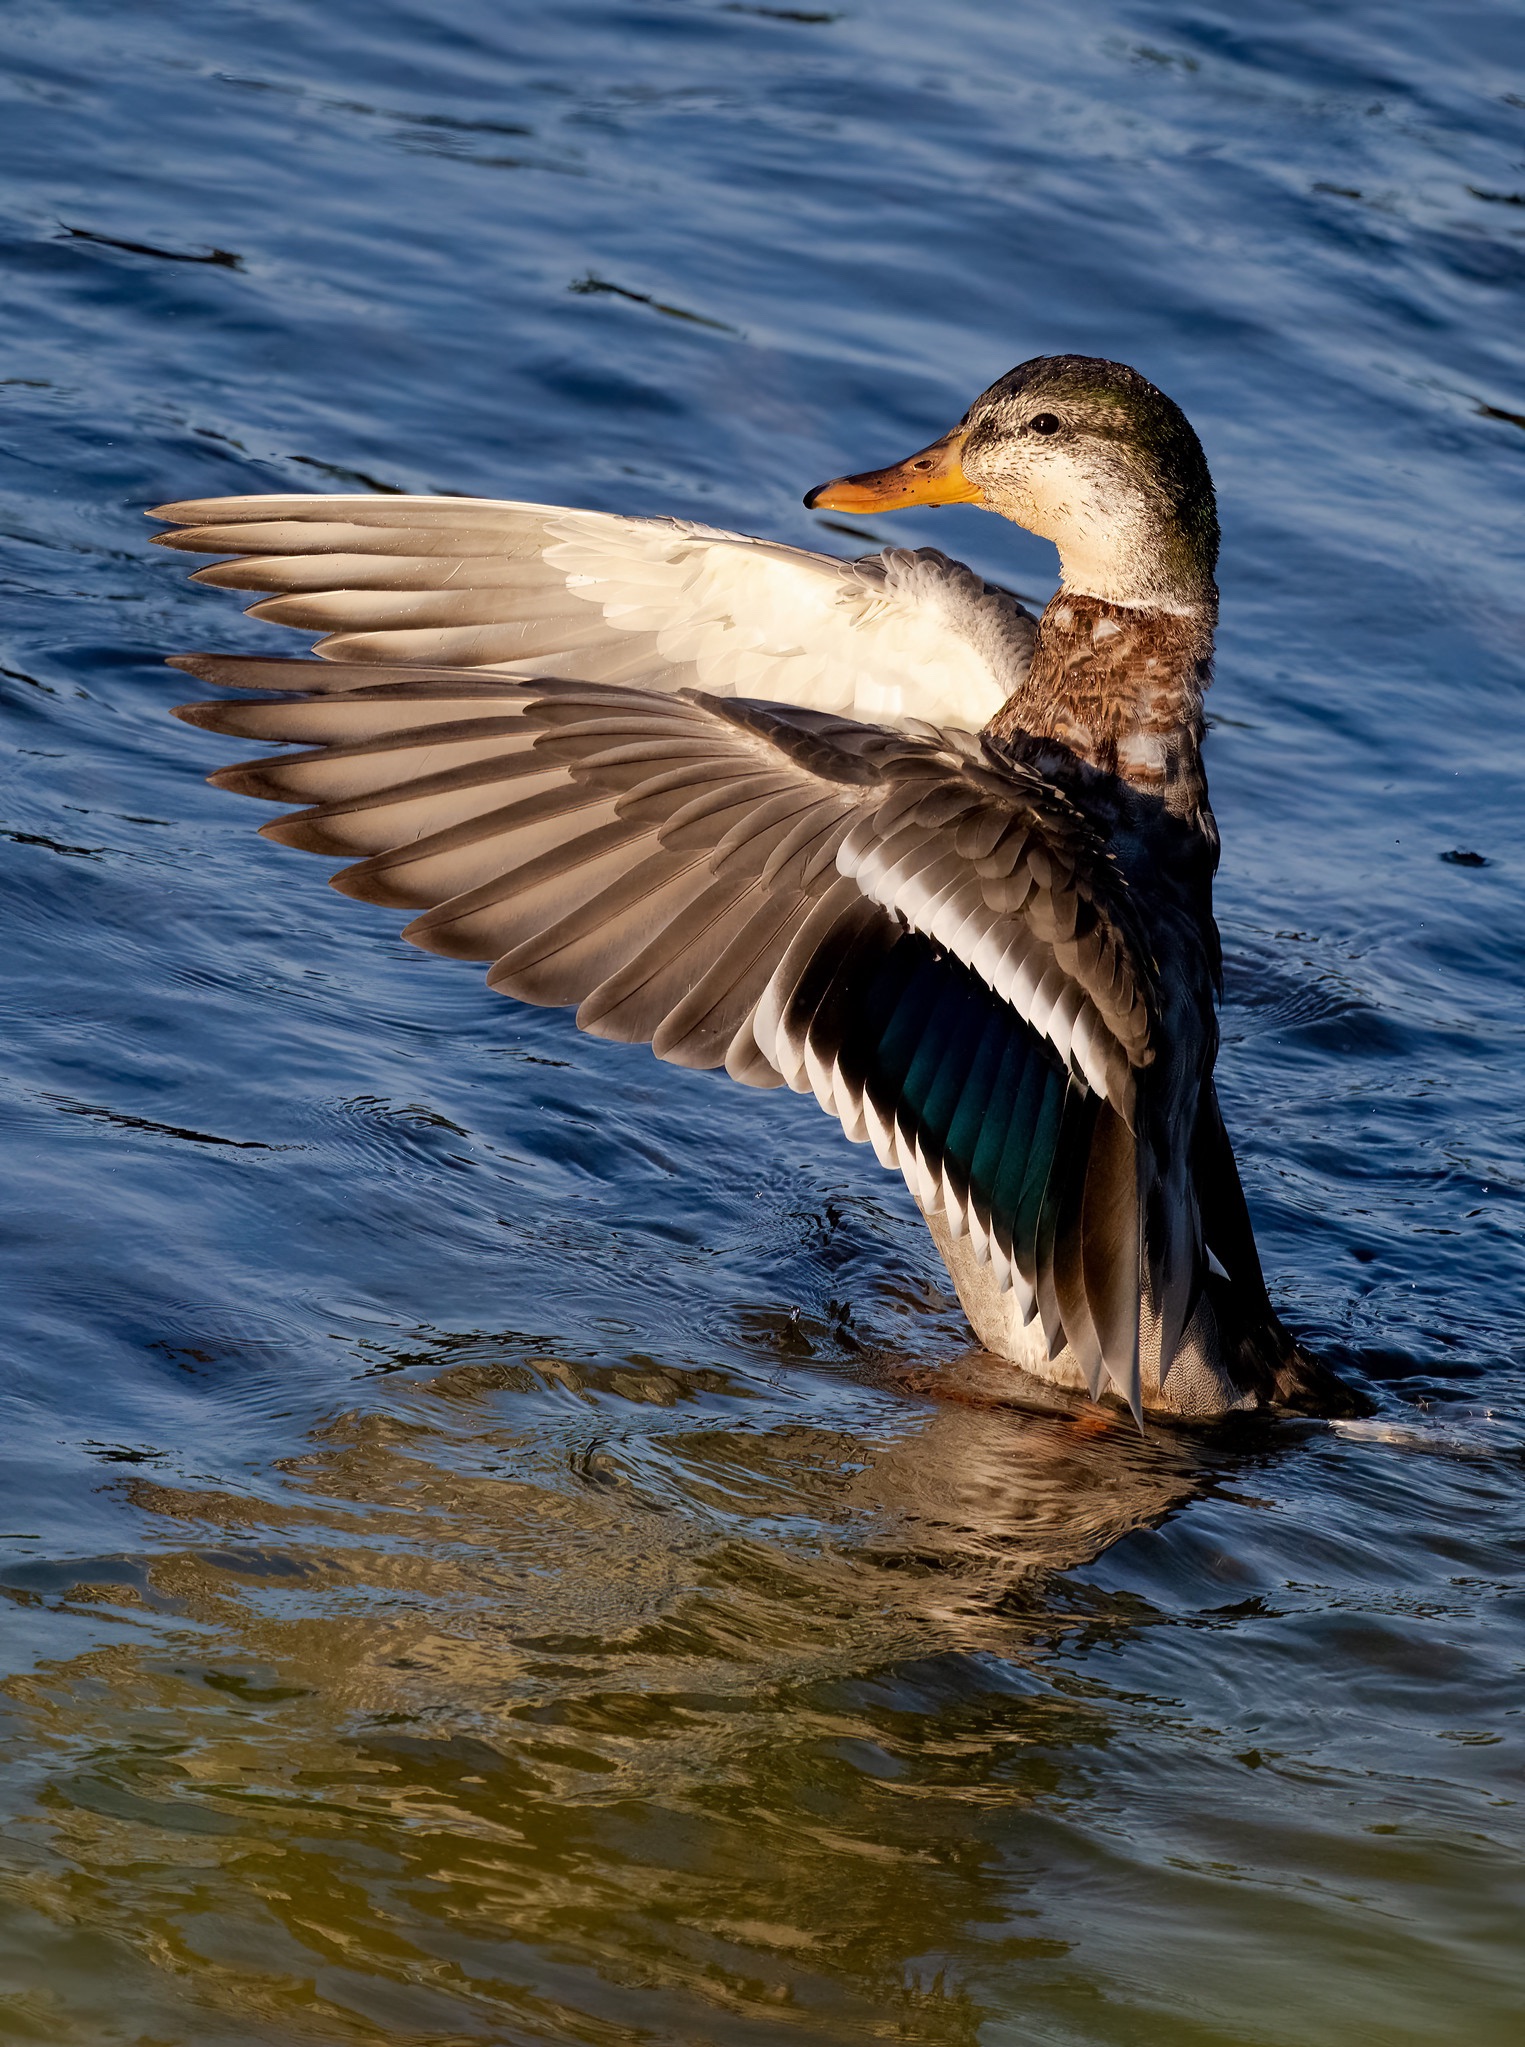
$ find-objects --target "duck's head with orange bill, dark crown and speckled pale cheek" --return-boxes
[804,356,1218,610]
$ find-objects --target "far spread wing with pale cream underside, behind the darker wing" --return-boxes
[154,495,1034,731]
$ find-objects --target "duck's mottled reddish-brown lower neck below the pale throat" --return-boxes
[985,590,1218,825]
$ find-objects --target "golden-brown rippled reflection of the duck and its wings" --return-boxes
[116,1335,1211,1694]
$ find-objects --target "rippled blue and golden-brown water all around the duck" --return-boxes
[0,0,1525,2047]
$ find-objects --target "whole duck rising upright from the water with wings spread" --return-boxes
[151,356,1361,1425]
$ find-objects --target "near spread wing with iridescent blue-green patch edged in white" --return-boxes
[178,655,1163,1400]
